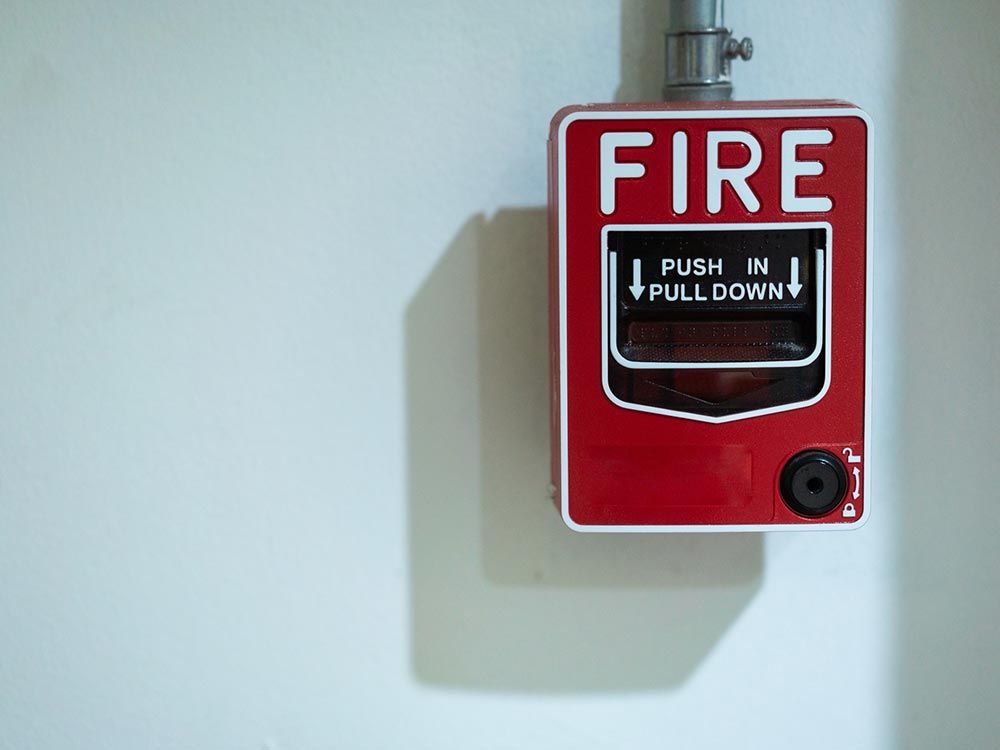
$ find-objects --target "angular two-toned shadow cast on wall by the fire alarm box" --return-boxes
[406,209,762,691]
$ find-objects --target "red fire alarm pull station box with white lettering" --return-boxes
[549,102,872,532]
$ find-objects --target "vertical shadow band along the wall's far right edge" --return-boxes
[891,0,1000,750]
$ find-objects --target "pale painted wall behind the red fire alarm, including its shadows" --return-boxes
[0,0,1000,750]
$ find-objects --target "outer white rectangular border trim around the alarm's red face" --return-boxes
[556,107,875,533]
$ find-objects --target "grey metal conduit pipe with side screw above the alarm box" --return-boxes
[663,0,753,101]
